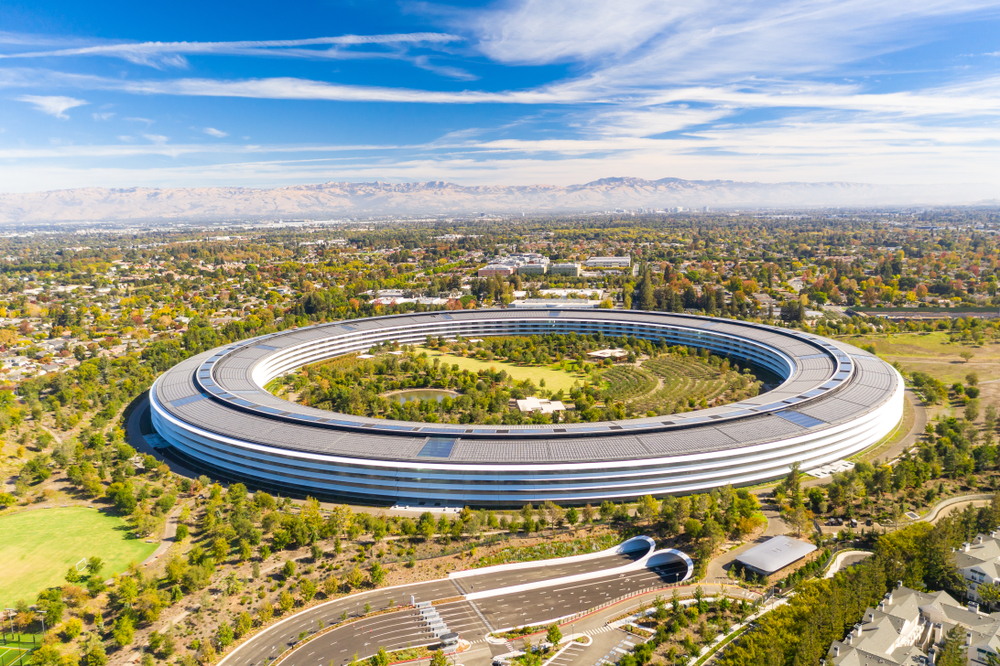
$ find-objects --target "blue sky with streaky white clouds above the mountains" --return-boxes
[0,0,1000,191]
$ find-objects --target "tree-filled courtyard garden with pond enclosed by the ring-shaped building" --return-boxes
[267,335,763,425]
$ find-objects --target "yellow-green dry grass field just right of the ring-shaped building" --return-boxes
[840,331,1000,384]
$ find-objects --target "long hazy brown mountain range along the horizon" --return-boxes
[0,178,993,224]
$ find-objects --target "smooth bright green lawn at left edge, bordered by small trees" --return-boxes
[0,507,157,608]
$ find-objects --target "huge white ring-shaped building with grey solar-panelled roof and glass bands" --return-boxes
[150,310,903,507]
